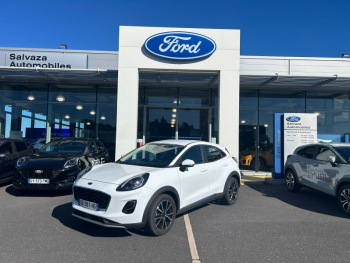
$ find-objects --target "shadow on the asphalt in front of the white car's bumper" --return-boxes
[52,202,133,237]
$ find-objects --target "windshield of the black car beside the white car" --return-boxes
[39,141,87,155]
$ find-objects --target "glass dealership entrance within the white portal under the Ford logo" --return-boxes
[138,71,219,143]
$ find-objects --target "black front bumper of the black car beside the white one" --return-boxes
[13,167,80,190]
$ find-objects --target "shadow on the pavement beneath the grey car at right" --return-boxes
[245,182,350,219]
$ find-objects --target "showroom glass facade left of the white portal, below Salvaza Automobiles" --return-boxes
[0,83,117,153]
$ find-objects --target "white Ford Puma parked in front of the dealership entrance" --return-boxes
[72,140,241,235]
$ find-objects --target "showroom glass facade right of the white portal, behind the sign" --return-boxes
[239,89,350,171]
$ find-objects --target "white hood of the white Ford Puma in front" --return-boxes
[81,163,162,185]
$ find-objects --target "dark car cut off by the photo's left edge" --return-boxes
[0,139,34,183]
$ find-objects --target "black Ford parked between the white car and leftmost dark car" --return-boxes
[13,138,109,190]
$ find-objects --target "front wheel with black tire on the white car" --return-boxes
[145,194,176,236]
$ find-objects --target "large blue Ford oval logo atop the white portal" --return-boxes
[145,31,216,60]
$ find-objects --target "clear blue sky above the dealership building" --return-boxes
[0,0,350,57]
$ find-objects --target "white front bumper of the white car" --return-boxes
[72,178,154,228]
